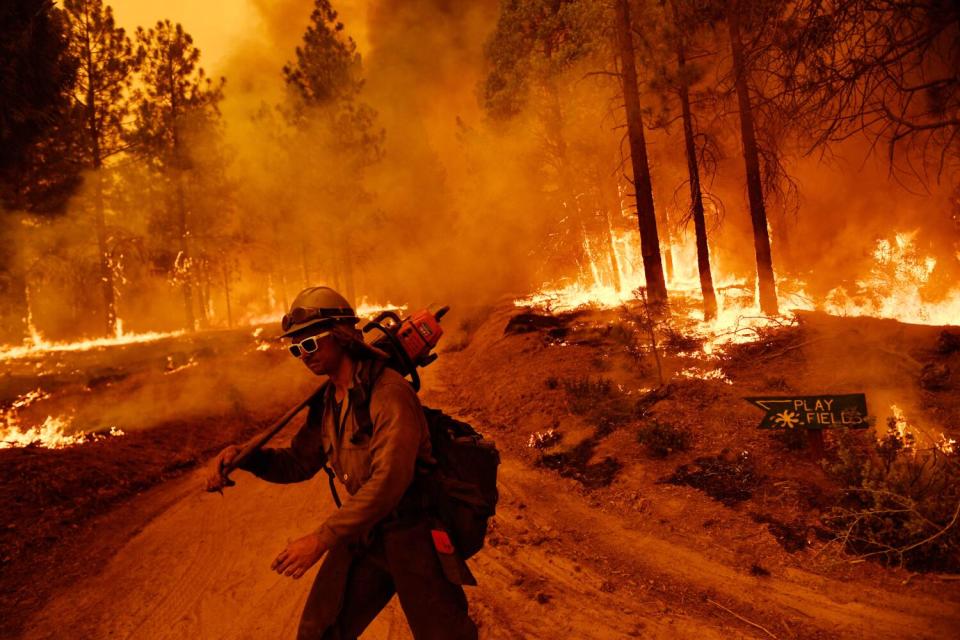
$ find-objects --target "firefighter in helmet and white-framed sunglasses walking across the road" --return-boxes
[208,287,477,640]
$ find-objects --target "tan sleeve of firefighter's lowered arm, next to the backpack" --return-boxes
[317,382,426,548]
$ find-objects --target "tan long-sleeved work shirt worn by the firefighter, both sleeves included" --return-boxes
[241,362,433,546]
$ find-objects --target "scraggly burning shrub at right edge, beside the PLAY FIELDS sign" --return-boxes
[823,418,960,571]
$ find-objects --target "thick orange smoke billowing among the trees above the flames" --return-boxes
[6,0,960,341]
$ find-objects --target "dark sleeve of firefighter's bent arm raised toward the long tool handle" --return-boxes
[239,407,327,484]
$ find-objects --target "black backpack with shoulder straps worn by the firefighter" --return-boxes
[324,367,500,559]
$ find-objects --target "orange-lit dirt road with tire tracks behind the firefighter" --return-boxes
[16,444,960,640]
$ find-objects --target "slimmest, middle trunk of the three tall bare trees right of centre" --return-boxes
[671,0,717,320]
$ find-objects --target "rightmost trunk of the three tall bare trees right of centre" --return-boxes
[727,0,779,315]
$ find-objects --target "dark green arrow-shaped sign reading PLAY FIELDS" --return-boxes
[744,393,869,429]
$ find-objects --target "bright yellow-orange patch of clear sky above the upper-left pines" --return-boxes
[106,0,366,75]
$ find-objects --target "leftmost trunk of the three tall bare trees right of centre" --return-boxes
[616,0,667,313]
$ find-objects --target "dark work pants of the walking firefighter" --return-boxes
[297,520,477,640]
